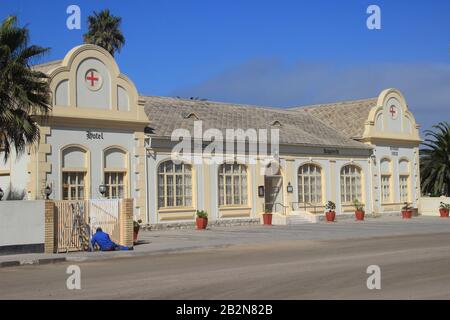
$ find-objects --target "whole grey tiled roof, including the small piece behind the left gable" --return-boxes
[33,60,376,149]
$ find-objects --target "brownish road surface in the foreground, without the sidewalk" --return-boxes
[0,233,450,299]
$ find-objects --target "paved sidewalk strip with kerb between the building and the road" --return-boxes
[0,217,450,268]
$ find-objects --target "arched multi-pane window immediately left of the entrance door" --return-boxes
[219,163,247,206]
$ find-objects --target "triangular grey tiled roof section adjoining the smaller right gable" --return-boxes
[289,98,377,139]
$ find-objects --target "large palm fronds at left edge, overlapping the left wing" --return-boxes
[0,16,51,161]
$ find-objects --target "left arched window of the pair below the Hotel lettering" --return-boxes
[62,146,88,200]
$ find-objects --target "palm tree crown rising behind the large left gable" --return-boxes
[83,9,125,56]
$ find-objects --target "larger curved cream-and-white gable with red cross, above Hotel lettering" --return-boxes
[50,45,144,116]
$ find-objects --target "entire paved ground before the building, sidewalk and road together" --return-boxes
[0,217,450,299]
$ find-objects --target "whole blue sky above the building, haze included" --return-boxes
[0,0,450,129]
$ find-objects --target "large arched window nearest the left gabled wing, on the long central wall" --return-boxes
[158,160,192,208]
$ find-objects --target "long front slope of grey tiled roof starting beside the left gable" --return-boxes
[141,96,370,149]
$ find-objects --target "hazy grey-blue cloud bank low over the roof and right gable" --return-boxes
[174,59,450,128]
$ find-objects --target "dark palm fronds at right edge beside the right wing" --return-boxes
[420,122,450,196]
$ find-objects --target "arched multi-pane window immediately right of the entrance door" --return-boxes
[298,164,322,203]
